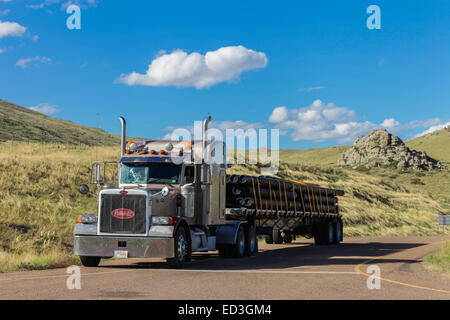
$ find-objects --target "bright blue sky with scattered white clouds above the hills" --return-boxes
[0,0,450,149]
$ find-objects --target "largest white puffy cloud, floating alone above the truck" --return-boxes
[117,46,268,89]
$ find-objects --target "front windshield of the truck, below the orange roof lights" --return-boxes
[120,163,181,184]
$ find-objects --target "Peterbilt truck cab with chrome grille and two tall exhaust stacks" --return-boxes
[74,117,257,267]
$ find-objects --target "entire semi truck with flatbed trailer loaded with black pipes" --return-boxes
[74,116,344,268]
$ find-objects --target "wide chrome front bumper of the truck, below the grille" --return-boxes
[74,235,175,258]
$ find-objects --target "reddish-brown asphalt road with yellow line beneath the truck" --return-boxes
[0,237,450,300]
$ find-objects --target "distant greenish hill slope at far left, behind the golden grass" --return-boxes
[0,100,120,145]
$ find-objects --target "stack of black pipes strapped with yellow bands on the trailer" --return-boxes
[226,175,344,213]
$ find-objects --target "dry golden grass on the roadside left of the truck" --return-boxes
[0,142,118,271]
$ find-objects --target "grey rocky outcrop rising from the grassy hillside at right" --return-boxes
[338,129,443,170]
